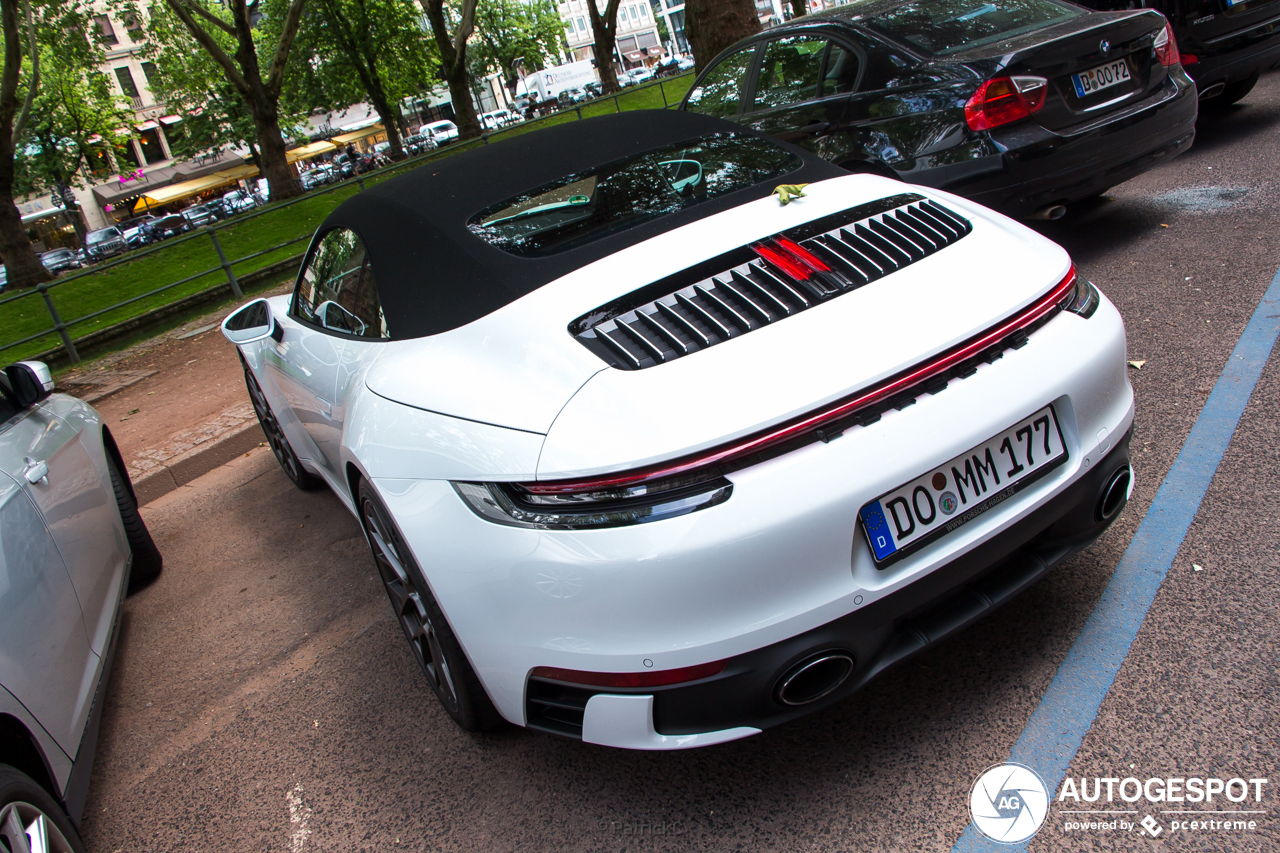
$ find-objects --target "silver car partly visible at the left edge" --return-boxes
[0,361,163,853]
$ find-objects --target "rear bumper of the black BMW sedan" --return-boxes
[941,74,1197,215]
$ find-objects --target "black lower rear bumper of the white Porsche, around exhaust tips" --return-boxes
[525,432,1132,738]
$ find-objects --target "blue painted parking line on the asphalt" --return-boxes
[952,262,1280,853]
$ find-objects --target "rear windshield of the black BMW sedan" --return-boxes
[865,0,1084,56]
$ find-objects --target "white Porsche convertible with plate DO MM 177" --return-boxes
[223,111,1133,749]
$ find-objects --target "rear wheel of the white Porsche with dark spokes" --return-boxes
[360,482,502,731]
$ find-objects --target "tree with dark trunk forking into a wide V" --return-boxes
[156,0,306,200]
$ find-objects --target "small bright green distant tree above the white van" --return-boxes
[471,0,568,87]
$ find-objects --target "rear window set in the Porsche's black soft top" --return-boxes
[467,133,803,257]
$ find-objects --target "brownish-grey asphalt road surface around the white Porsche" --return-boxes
[84,74,1280,853]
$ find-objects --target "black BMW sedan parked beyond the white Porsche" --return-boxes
[681,0,1197,218]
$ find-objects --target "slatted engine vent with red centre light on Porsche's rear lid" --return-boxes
[570,193,973,370]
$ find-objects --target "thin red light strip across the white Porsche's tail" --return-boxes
[522,262,1076,494]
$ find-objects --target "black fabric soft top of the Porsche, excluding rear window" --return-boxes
[317,110,847,339]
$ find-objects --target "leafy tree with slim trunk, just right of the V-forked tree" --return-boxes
[296,0,439,159]
